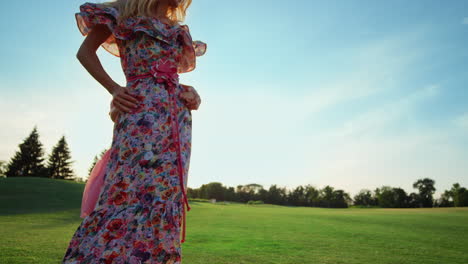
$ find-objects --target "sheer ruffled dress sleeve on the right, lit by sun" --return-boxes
[177,25,207,73]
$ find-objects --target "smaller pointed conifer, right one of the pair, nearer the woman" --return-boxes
[47,136,75,180]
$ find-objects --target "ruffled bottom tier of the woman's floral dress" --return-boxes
[64,201,182,263]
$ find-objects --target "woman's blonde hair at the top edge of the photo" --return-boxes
[102,0,192,24]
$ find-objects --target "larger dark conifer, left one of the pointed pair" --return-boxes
[6,126,47,177]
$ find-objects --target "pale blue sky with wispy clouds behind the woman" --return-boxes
[0,0,468,197]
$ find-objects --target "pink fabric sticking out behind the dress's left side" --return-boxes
[80,148,111,218]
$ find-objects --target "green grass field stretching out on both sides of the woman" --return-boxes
[0,178,468,264]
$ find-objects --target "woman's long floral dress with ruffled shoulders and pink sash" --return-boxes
[62,2,207,264]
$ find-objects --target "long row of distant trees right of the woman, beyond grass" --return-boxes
[187,178,468,208]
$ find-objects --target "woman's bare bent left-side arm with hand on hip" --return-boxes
[76,24,138,112]
